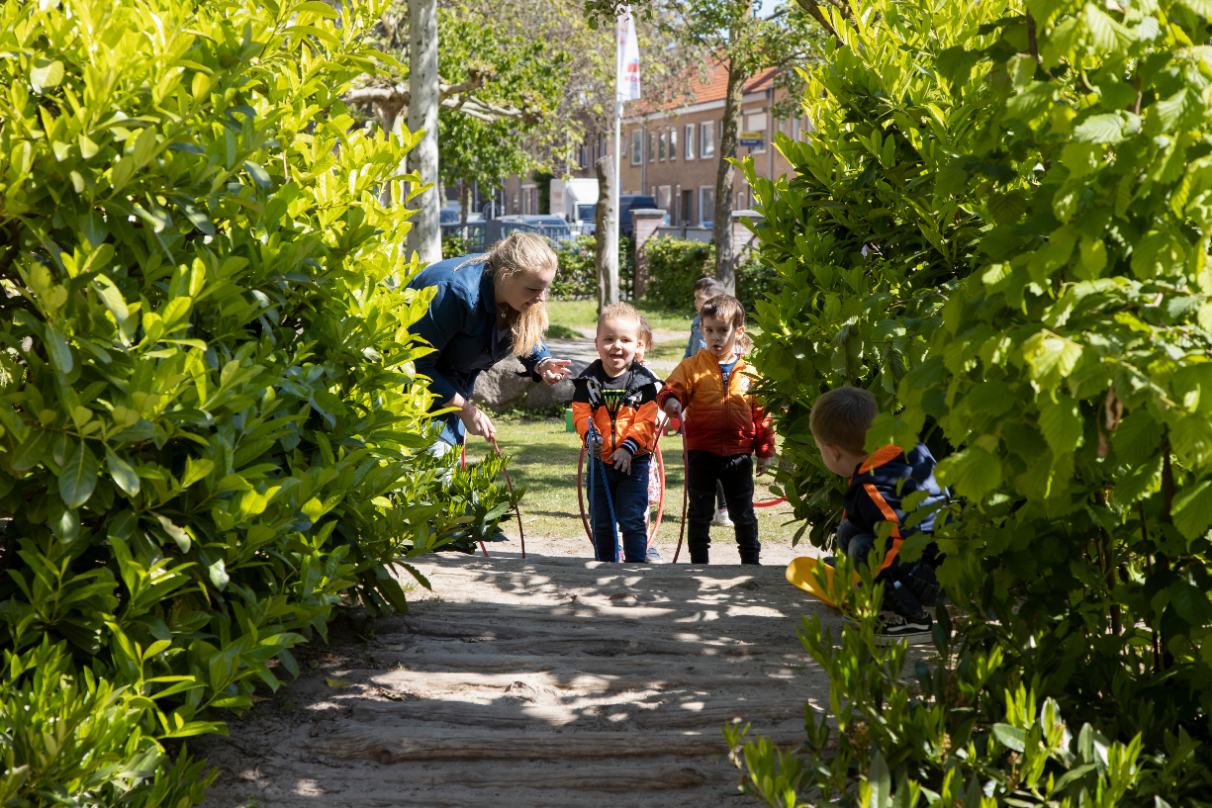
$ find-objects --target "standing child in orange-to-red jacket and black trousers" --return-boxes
[657,294,774,565]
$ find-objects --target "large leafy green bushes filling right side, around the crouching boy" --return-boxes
[742,0,1212,806]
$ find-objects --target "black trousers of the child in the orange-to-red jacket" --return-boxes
[686,449,761,565]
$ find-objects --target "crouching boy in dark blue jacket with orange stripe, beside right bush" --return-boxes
[808,386,947,644]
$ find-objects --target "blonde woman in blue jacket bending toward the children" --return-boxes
[408,233,571,446]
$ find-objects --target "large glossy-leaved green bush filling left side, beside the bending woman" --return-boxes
[0,0,510,806]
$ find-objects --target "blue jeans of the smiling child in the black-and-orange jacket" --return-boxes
[588,454,651,563]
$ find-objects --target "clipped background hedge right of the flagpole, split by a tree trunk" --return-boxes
[644,237,777,311]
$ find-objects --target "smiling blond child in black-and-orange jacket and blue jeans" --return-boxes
[572,303,657,563]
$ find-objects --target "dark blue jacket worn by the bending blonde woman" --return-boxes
[408,256,551,446]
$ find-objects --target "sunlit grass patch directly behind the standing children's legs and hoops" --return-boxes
[467,414,799,562]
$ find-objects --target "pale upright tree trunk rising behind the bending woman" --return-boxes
[408,0,442,264]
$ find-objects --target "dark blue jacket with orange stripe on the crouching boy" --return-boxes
[842,443,947,569]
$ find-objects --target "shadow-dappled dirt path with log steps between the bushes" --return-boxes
[191,550,840,808]
